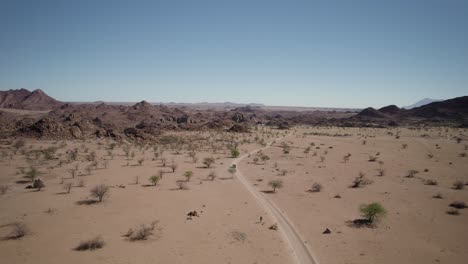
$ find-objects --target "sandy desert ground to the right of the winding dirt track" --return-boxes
[240,128,468,263]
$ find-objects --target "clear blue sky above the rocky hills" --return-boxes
[0,0,468,107]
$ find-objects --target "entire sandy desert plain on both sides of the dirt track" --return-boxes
[0,127,468,263]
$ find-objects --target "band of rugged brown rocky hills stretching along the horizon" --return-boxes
[0,89,468,140]
